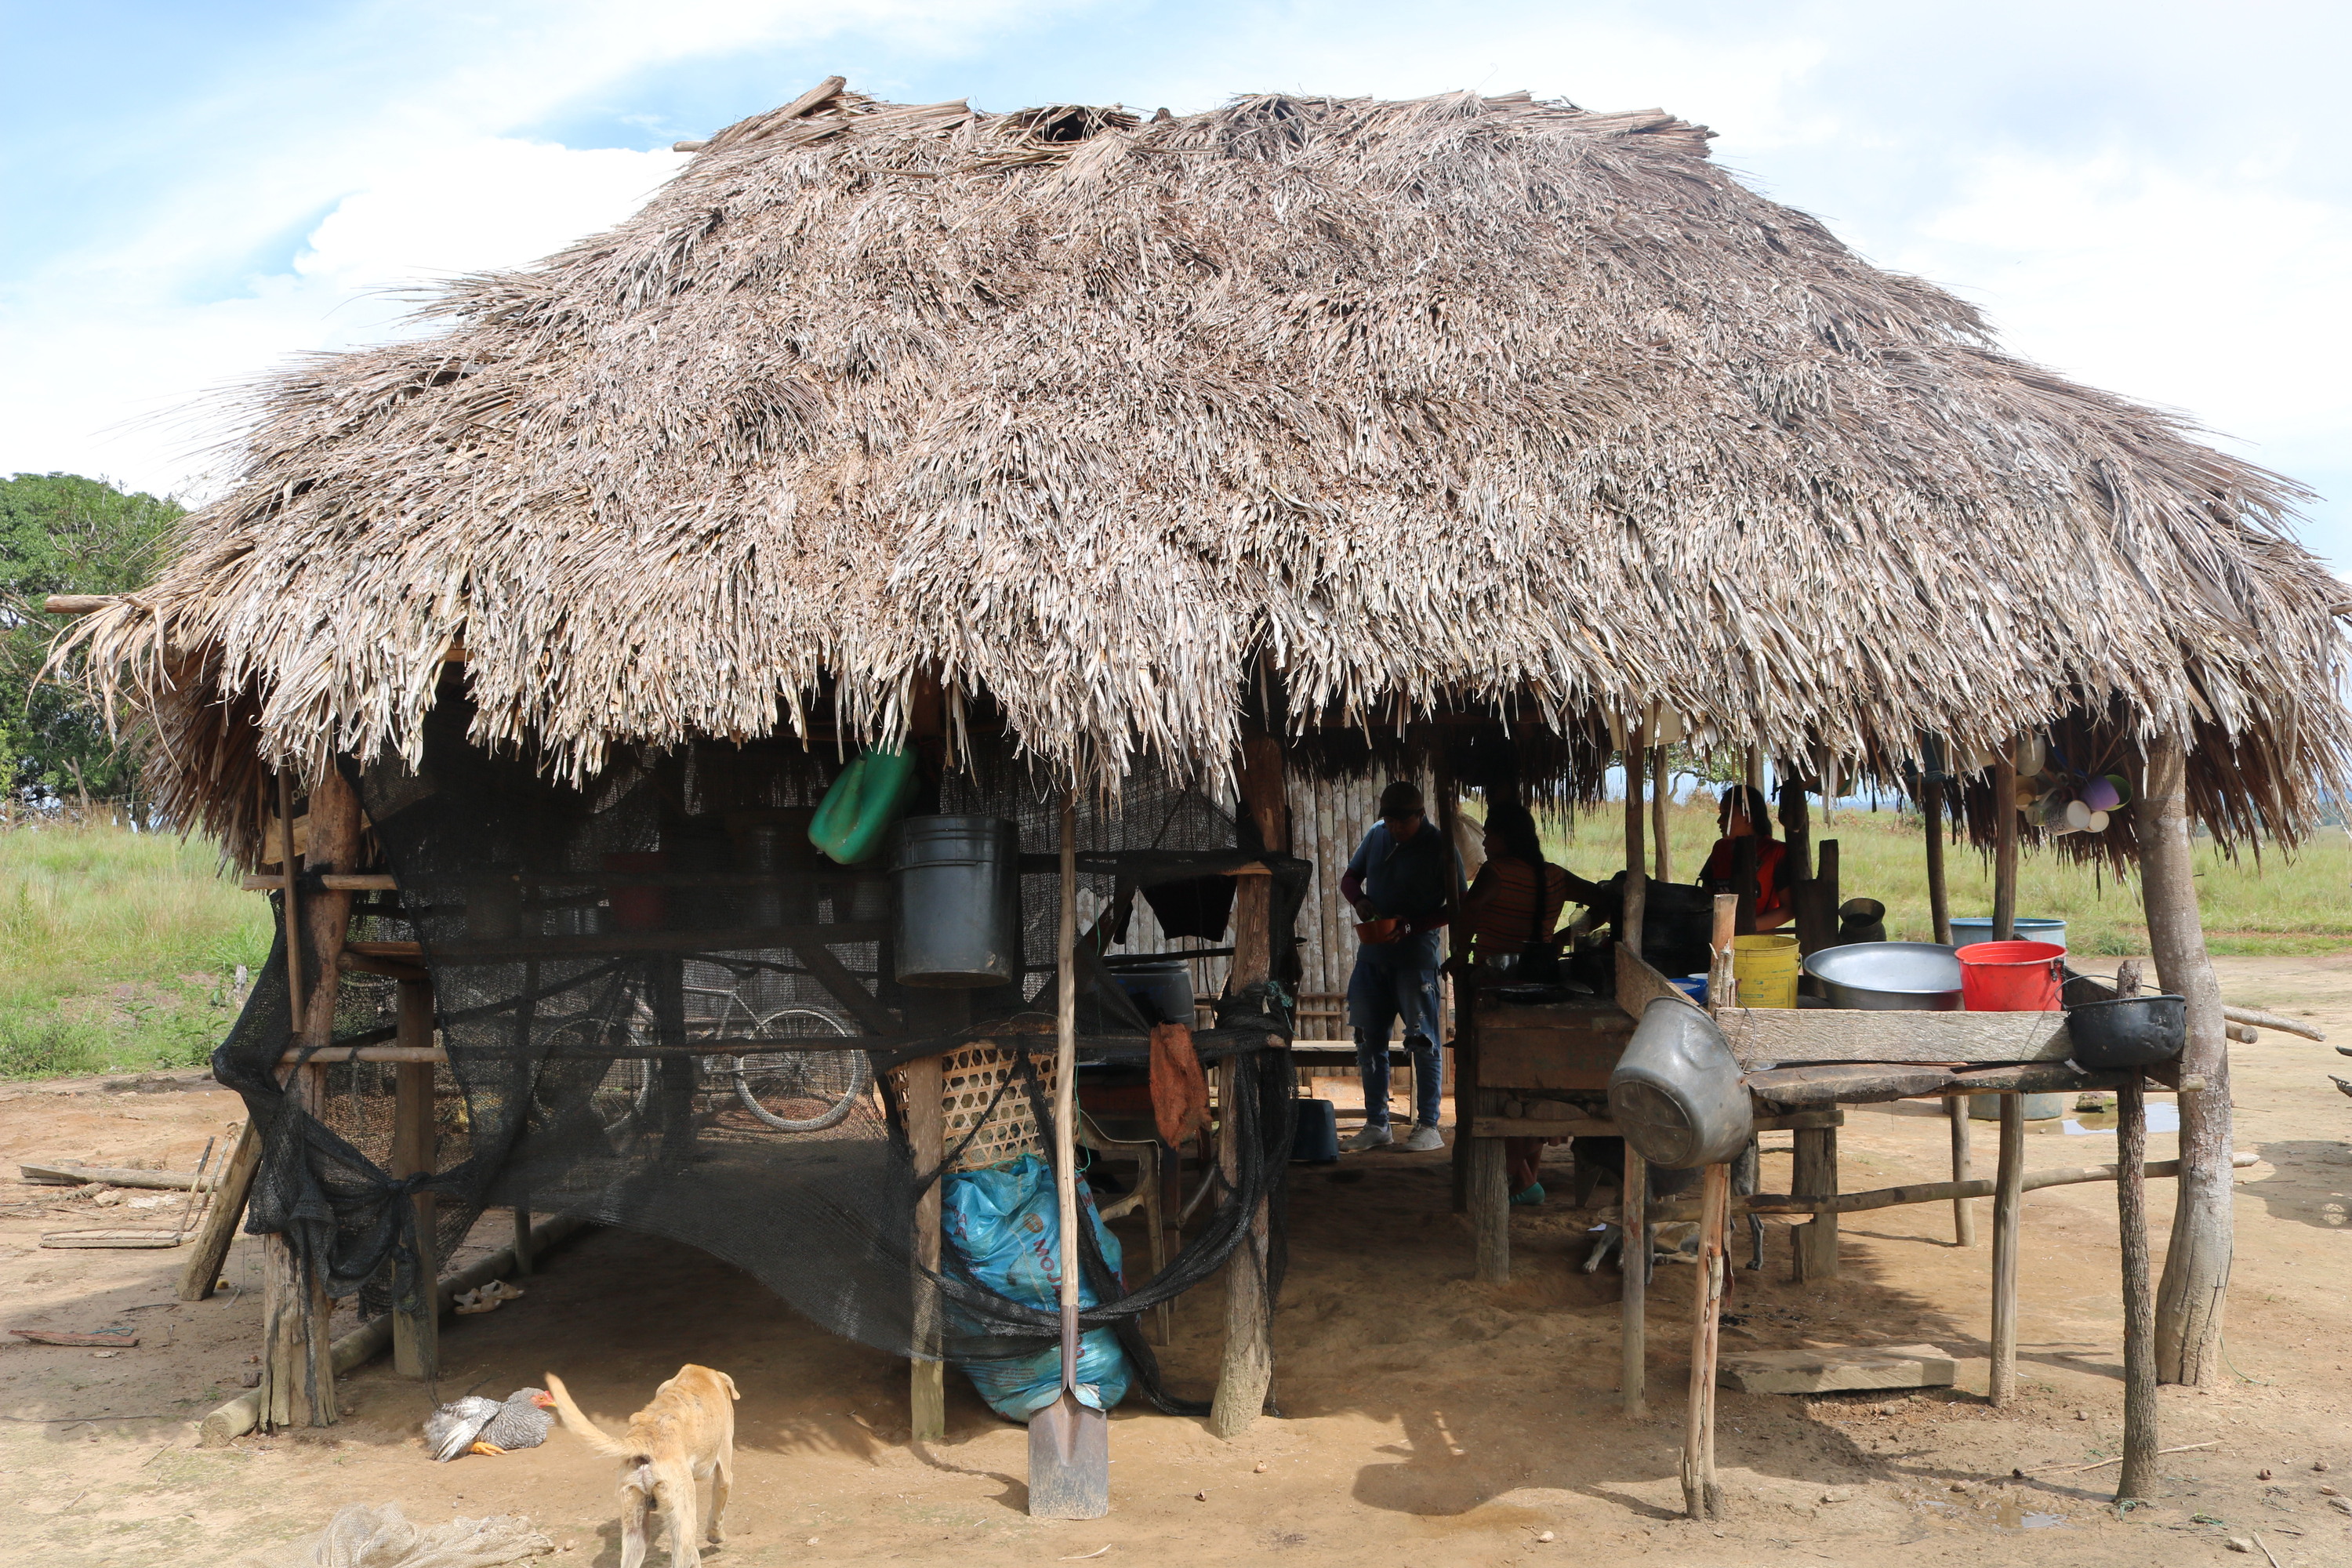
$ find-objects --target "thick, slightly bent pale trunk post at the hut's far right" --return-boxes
[2133,739,2237,1385]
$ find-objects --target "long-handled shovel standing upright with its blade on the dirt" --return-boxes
[1030,789,1110,1519]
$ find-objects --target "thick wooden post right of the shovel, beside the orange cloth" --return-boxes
[1209,734,1289,1439]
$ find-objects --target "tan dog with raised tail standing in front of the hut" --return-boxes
[548,1363,741,1568]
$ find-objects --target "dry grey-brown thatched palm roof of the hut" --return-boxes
[64,89,2352,846]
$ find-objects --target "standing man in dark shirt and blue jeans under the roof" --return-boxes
[1338,779,1454,1152]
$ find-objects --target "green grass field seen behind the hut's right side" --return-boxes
[1545,804,2352,956]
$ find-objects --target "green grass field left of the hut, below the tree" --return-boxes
[0,825,270,1076]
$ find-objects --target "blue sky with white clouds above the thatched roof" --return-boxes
[0,0,2352,572]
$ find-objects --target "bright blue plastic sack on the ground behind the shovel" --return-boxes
[941,1154,1134,1425]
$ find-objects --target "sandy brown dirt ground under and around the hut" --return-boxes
[0,952,2352,1568]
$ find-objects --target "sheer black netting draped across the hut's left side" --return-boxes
[214,696,1308,1410]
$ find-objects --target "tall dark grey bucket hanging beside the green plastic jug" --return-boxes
[889,815,1021,989]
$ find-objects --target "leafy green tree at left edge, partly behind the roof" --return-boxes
[0,473,186,801]
